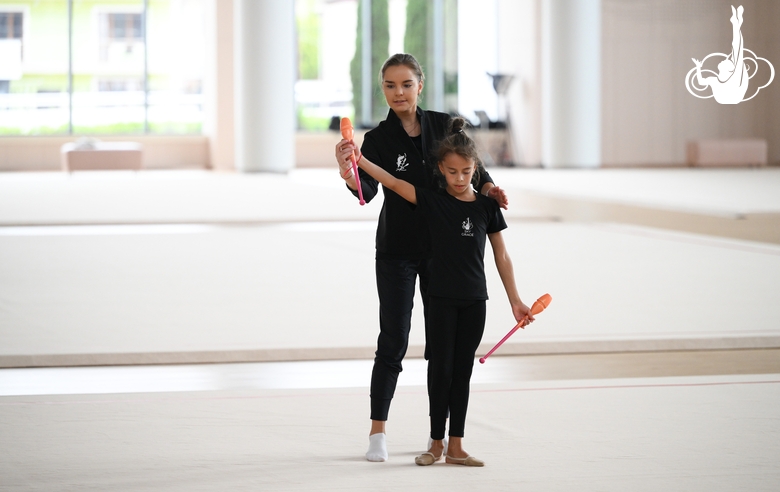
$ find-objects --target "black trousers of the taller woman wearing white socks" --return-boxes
[371,259,428,420]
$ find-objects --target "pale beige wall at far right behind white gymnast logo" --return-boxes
[602,0,780,165]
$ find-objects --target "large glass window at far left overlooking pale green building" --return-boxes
[0,0,205,135]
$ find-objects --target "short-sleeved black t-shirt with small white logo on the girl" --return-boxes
[415,187,507,300]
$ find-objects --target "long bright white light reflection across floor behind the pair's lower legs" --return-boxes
[0,357,544,396]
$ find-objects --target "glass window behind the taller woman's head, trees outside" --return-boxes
[295,0,458,131]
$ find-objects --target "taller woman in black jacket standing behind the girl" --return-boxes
[336,54,508,461]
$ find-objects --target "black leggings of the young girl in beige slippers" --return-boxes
[427,296,485,439]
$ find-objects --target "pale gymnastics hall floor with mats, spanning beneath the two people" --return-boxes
[0,168,780,491]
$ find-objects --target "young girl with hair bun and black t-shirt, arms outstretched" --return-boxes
[352,118,534,466]
